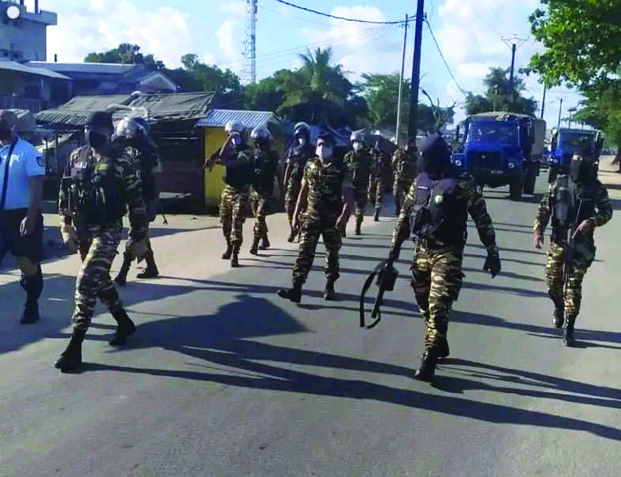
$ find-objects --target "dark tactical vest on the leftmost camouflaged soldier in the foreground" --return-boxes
[62,151,125,227]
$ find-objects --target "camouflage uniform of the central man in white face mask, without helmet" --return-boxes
[293,158,353,286]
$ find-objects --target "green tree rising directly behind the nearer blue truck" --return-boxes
[465,68,537,115]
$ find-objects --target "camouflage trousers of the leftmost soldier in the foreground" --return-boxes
[73,228,123,331]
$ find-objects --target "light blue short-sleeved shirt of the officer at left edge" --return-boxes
[0,137,45,209]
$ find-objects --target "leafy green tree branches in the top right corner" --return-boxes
[529,0,621,89]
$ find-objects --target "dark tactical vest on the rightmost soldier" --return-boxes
[552,175,595,240]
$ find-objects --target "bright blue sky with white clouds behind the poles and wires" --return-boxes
[26,0,581,126]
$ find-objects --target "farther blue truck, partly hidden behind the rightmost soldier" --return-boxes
[548,128,604,182]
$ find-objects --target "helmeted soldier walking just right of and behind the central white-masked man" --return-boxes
[344,131,372,235]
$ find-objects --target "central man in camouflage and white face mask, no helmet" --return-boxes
[278,134,353,303]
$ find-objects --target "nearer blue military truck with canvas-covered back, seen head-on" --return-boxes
[452,112,546,200]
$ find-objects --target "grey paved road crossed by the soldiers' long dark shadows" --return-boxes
[0,165,621,476]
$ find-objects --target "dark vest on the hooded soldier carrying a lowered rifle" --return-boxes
[410,173,468,247]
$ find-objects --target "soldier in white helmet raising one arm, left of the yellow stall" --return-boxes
[207,121,252,268]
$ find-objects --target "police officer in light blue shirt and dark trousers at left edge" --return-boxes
[0,110,45,324]
